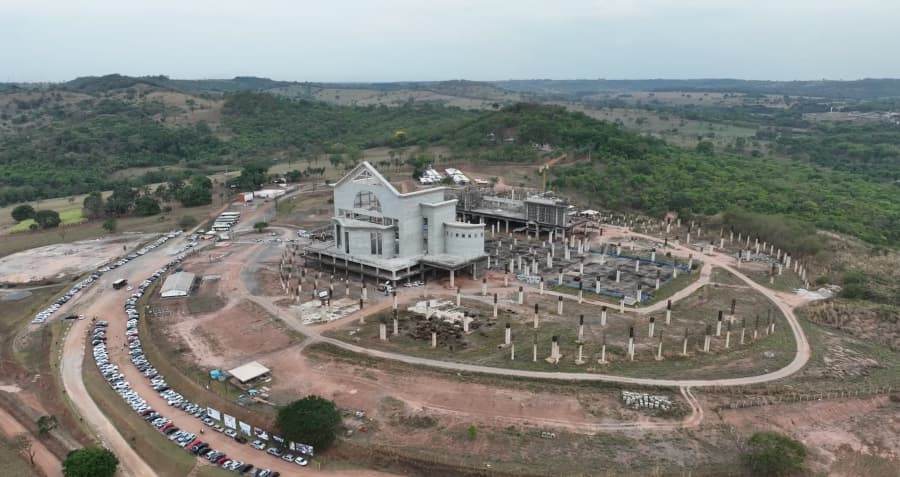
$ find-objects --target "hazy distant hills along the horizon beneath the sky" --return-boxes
[7,74,900,100]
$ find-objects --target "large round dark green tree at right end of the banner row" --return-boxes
[275,396,341,452]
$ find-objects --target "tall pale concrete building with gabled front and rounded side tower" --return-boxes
[307,162,487,281]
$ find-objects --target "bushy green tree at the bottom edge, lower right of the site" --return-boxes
[744,431,806,476]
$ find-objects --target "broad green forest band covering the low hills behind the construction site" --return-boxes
[0,91,900,246]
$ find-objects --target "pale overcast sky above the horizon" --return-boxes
[0,0,900,81]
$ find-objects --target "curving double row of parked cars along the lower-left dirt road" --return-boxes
[91,233,309,477]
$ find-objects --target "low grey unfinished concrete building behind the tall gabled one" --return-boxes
[448,185,585,236]
